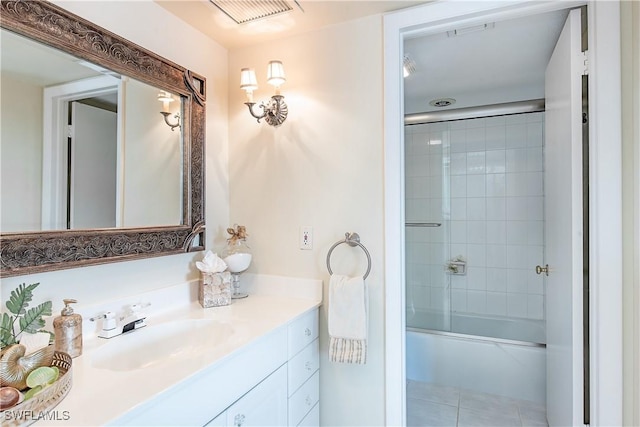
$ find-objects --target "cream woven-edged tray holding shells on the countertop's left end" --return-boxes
[0,351,72,427]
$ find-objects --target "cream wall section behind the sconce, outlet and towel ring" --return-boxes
[229,16,384,426]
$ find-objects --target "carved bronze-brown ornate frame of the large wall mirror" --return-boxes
[0,0,206,277]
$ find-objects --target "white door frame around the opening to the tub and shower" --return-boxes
[384,0,623,426]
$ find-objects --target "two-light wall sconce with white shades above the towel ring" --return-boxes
[240,61,289,126]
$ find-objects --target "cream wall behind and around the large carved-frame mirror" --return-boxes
[1,1,229,320]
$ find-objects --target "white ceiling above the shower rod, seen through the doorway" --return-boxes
[404,10,568,113]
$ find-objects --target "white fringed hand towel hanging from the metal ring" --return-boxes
[328,274,368,364]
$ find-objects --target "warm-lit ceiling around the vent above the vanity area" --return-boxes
[154,0,427,49]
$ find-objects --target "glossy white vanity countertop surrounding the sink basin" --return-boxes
[29,274,322,426]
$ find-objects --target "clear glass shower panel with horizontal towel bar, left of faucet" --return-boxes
[405,123,451,331]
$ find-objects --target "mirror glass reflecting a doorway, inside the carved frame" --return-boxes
[0,29,184,233]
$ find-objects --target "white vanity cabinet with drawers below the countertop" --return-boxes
[114,308,319,427]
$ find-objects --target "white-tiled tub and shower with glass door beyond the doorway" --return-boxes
[405,100,546,404]
